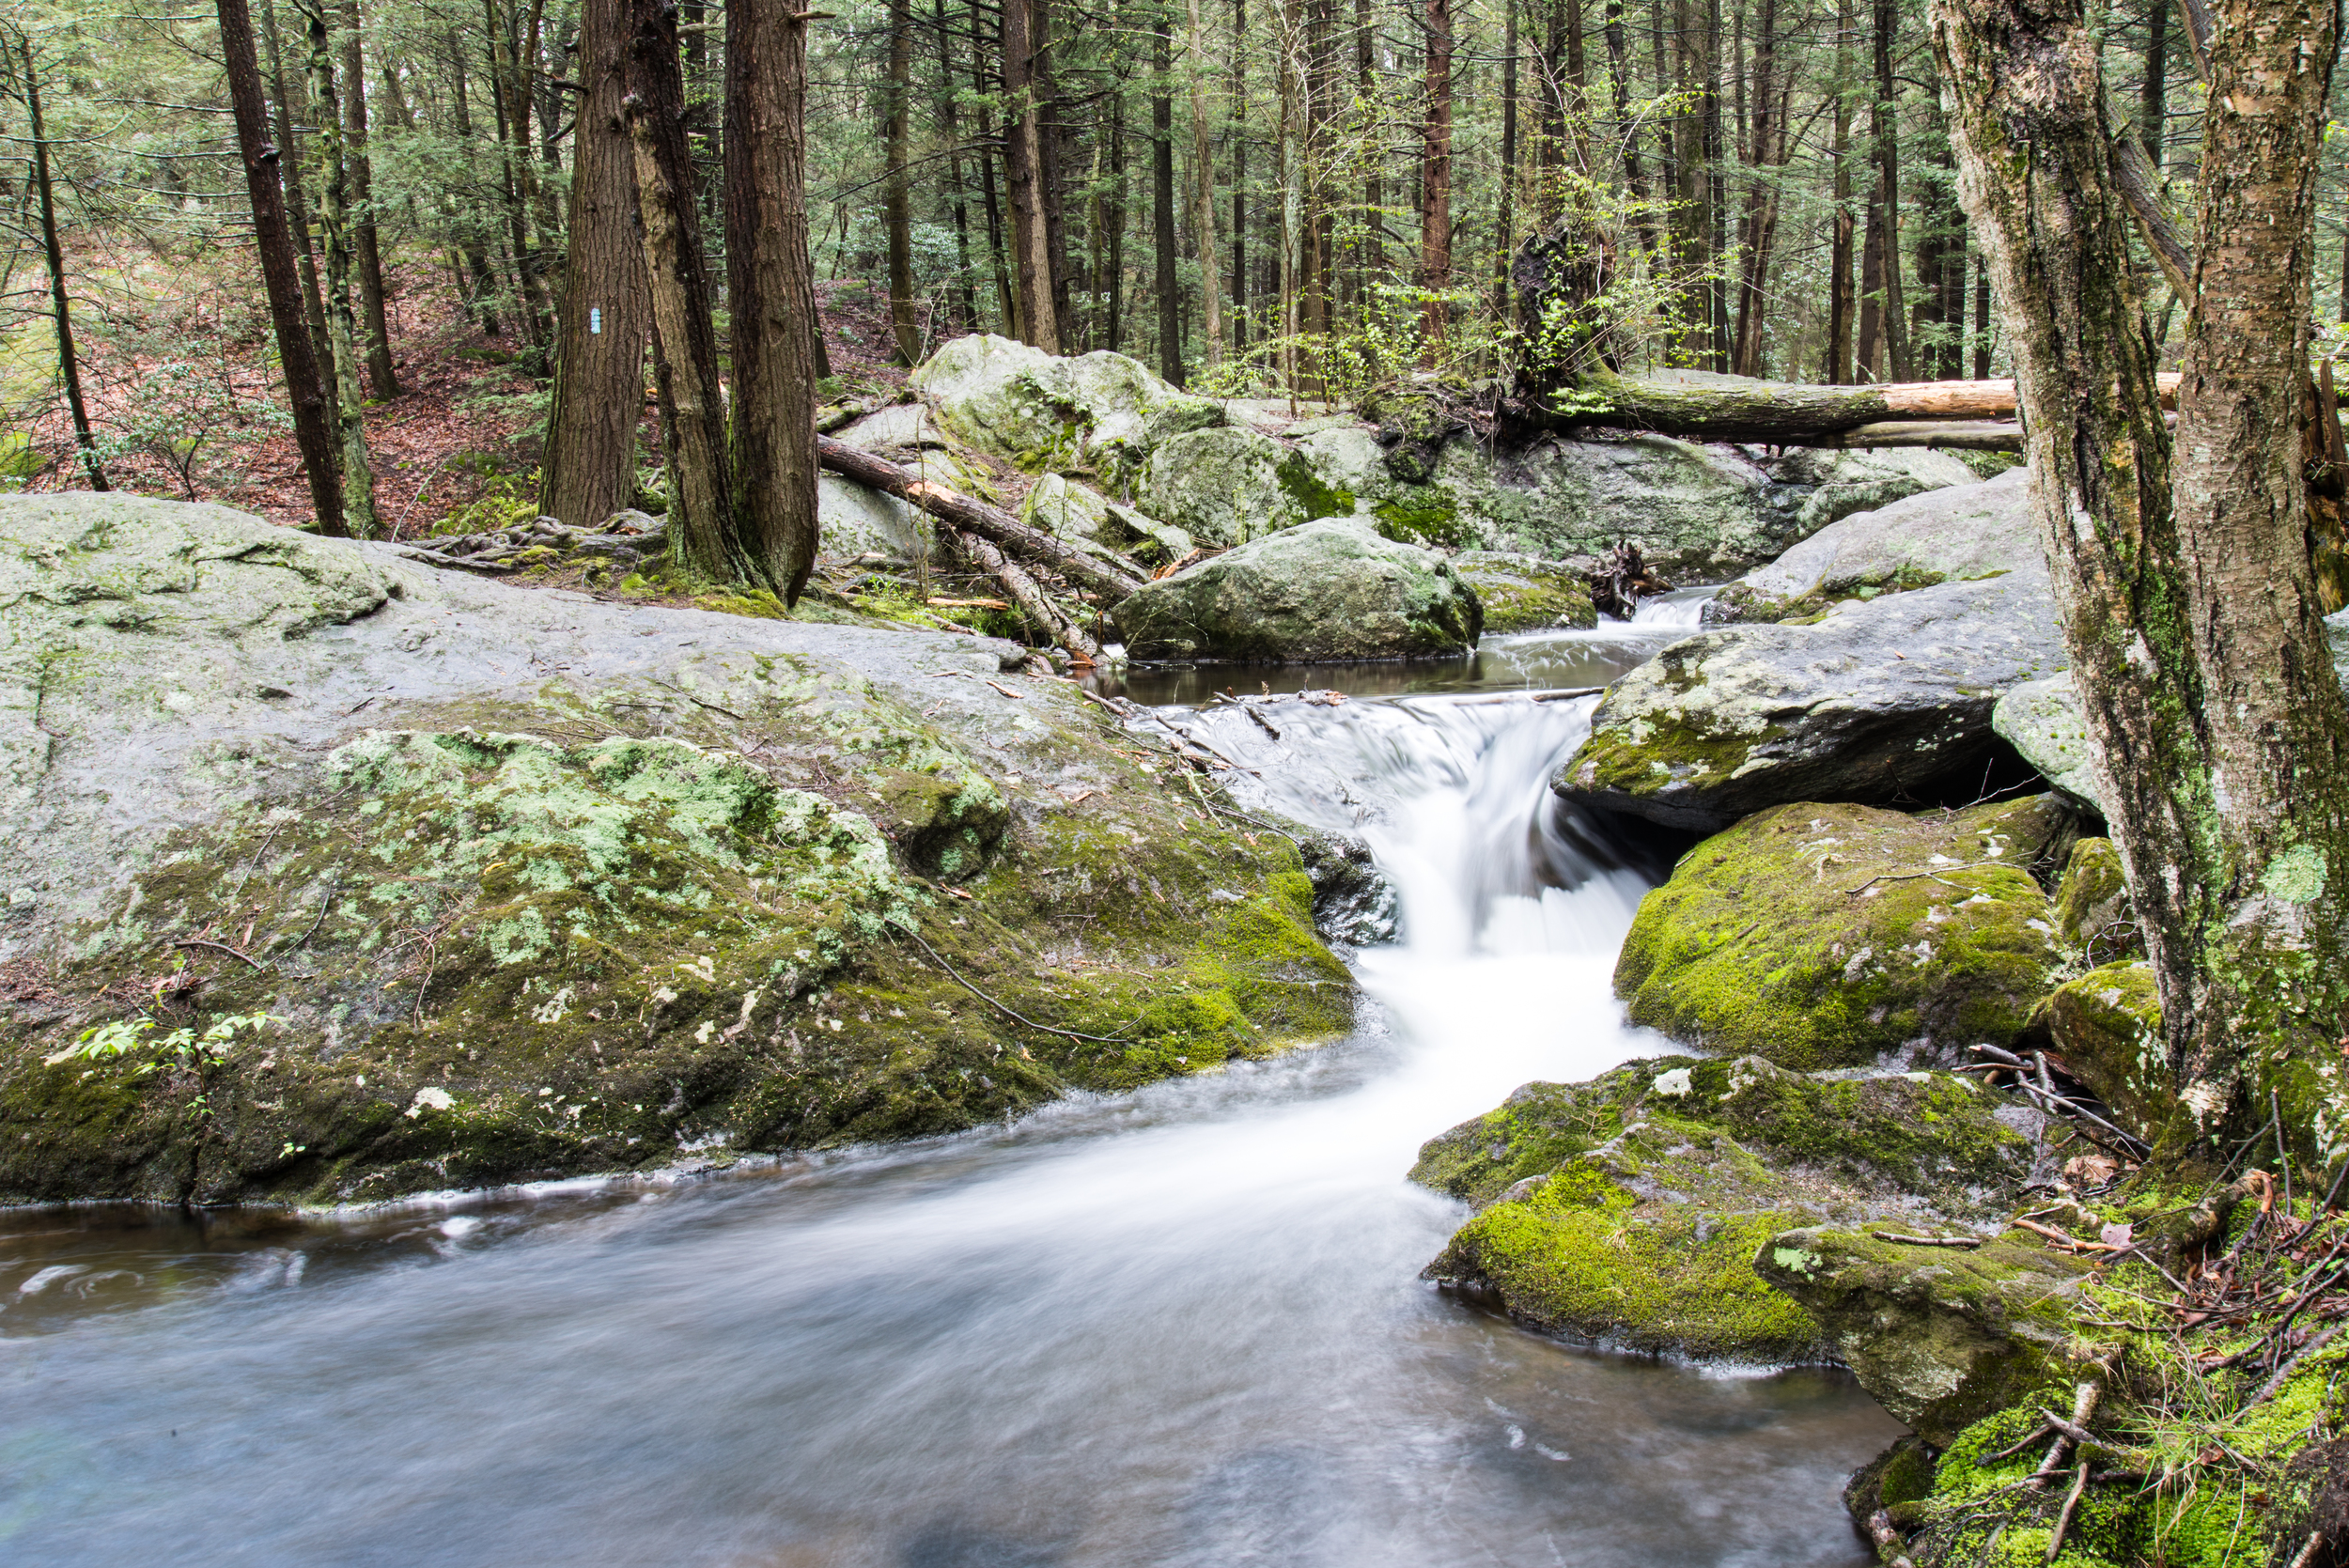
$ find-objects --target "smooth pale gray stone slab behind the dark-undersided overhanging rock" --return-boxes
[1705,470,2044,625]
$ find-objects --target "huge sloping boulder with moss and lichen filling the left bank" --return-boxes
[0,495,1353,1202]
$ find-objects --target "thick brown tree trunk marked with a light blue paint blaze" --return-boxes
[538,0,653,528]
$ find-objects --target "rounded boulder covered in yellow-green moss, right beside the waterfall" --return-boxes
[1616,796,2072,1070]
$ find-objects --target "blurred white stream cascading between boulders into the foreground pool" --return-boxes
[0,598,1901,1568]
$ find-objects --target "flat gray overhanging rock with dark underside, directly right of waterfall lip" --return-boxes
[1550,570,2067,833]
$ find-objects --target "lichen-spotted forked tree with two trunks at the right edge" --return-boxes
[1931,0,2349,1159]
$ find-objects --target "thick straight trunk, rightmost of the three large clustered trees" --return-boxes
[726,0,822,603]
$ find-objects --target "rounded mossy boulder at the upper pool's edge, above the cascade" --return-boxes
[1113,517,1485,664]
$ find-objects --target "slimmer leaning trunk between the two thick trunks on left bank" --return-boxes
[623,0,742,582]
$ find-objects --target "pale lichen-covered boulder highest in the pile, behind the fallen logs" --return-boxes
[907,334,1224,484]
